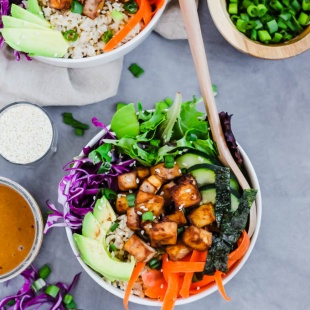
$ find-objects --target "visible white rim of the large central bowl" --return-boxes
[66,125,262,307]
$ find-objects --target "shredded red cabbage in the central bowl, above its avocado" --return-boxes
[44,118,135,233]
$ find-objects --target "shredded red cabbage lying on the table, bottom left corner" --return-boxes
[0,266,80,310]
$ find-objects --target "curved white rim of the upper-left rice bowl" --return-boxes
[33,0,171,64]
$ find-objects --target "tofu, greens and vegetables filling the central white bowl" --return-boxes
[45,93,256,309]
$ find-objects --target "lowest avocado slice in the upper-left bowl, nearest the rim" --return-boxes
[1,28,69,57]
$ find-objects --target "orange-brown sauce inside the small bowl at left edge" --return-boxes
[0,183,36,276]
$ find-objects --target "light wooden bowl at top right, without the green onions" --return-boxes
[207,0,310,59]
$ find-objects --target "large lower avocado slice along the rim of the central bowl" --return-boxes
[73,234,135,281]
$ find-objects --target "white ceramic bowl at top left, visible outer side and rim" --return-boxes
[34,0,170,68]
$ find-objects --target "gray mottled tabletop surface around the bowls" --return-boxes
[0,2,310,310]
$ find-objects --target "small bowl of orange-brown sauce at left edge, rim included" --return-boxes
[0,177,43,282]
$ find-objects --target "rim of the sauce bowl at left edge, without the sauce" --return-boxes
[0,176,43,282]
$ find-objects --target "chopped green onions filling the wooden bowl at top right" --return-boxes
[227,0,310,44]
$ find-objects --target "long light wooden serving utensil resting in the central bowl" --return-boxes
[179,0,256,237]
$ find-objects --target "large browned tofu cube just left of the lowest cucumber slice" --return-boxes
[172,183,201,209]
